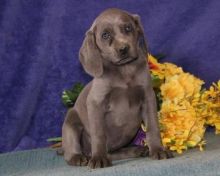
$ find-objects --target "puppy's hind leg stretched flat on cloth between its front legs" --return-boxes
[108,146,149,160]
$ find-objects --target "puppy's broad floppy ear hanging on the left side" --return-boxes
[79,30,103,77]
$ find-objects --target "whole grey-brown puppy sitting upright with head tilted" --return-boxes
[62,9,172,168]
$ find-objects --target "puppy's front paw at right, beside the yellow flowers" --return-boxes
[150,147,174,160]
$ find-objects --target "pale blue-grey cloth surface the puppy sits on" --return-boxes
[0,133,220,176]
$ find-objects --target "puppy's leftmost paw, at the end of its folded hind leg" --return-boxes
[67,154,88,166]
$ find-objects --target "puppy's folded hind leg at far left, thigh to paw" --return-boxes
[62,108,88,166]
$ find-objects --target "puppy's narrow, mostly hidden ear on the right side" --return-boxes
[132,14,148,54]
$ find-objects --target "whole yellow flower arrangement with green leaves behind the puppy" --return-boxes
[48,55,220,154]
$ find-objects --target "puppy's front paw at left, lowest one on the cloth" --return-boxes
[88,156,112,169]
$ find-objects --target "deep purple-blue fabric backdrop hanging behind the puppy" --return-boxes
[0,0,220,152]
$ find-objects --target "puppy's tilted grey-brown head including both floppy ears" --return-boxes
[80,9,147,77]
